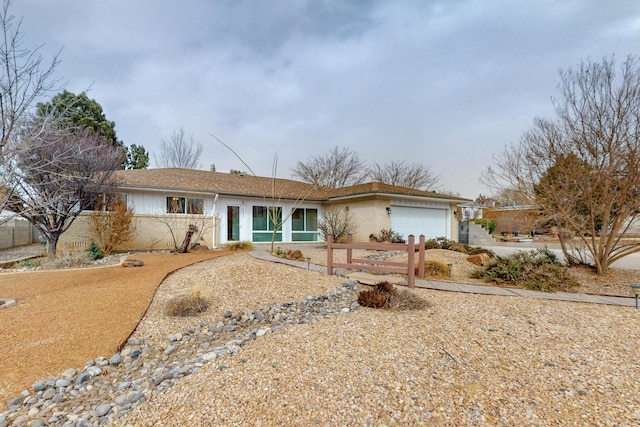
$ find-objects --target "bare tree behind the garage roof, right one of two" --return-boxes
[369,160,440,191]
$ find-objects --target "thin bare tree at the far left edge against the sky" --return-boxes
[0,0,59,217]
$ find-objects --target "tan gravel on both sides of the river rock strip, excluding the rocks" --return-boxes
[117,252,640,426]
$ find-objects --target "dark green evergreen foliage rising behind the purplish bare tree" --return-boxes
[38,90,149,169]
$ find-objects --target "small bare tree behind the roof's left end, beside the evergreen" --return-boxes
[153,127,202,169]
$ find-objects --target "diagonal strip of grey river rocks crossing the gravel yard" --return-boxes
[0,280,359,427]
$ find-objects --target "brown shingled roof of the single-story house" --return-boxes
[114,168,469,202]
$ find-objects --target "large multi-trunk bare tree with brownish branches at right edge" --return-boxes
[483,57,640,274]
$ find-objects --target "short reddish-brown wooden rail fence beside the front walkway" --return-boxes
[327,234,424,288]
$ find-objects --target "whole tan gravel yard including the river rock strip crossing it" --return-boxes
[0,254,640,426]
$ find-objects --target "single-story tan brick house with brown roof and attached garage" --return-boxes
[60,169,469,250]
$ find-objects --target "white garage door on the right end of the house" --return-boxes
[391,206,451,240]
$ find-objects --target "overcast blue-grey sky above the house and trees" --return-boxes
[11,0,640,199]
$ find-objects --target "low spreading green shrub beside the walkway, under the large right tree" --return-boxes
[472,248,578,292]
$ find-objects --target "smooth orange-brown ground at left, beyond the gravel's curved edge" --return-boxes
[0,251,228,411]
